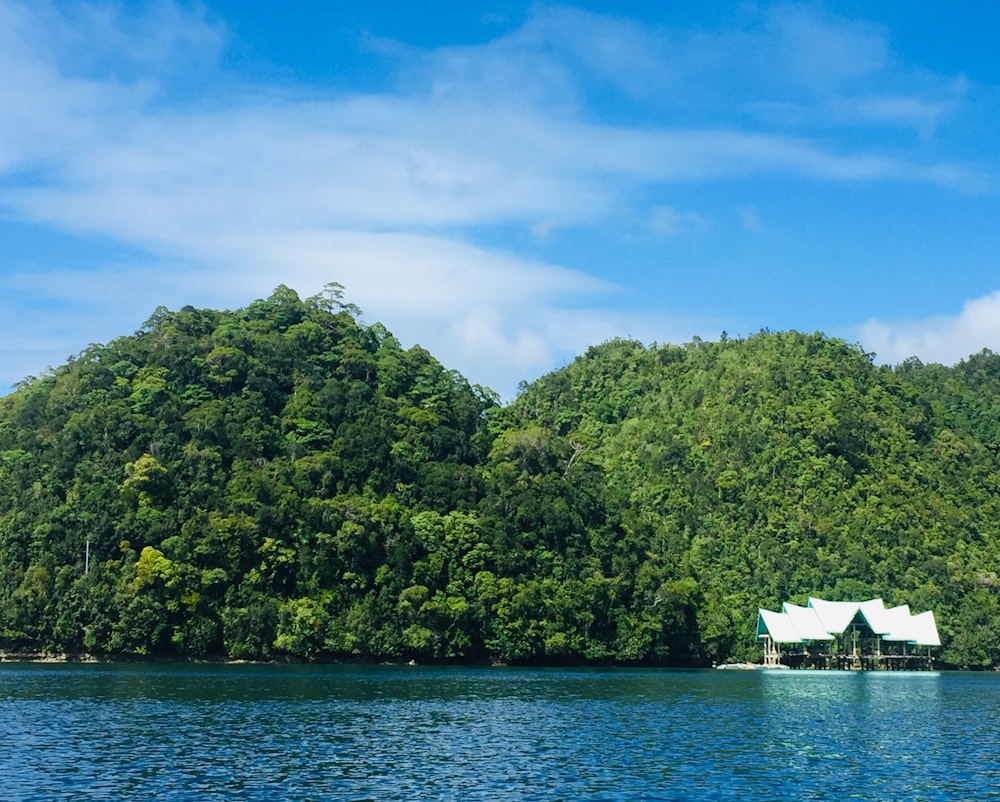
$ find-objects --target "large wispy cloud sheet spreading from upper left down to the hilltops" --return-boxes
[0,0,980,396]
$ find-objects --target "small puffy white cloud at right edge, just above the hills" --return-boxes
[858,291,1000,364]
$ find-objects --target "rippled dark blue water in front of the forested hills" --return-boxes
[0,664,1000,802]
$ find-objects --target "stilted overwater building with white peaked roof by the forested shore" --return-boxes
[757,597,941,670]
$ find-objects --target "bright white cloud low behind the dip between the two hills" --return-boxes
[220,231,632,398]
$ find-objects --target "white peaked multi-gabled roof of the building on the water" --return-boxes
[757,596,941,646]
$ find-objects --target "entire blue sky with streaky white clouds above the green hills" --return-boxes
[0,0,1000,400]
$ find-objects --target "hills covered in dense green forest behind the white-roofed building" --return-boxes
[0,285,1000,666]
